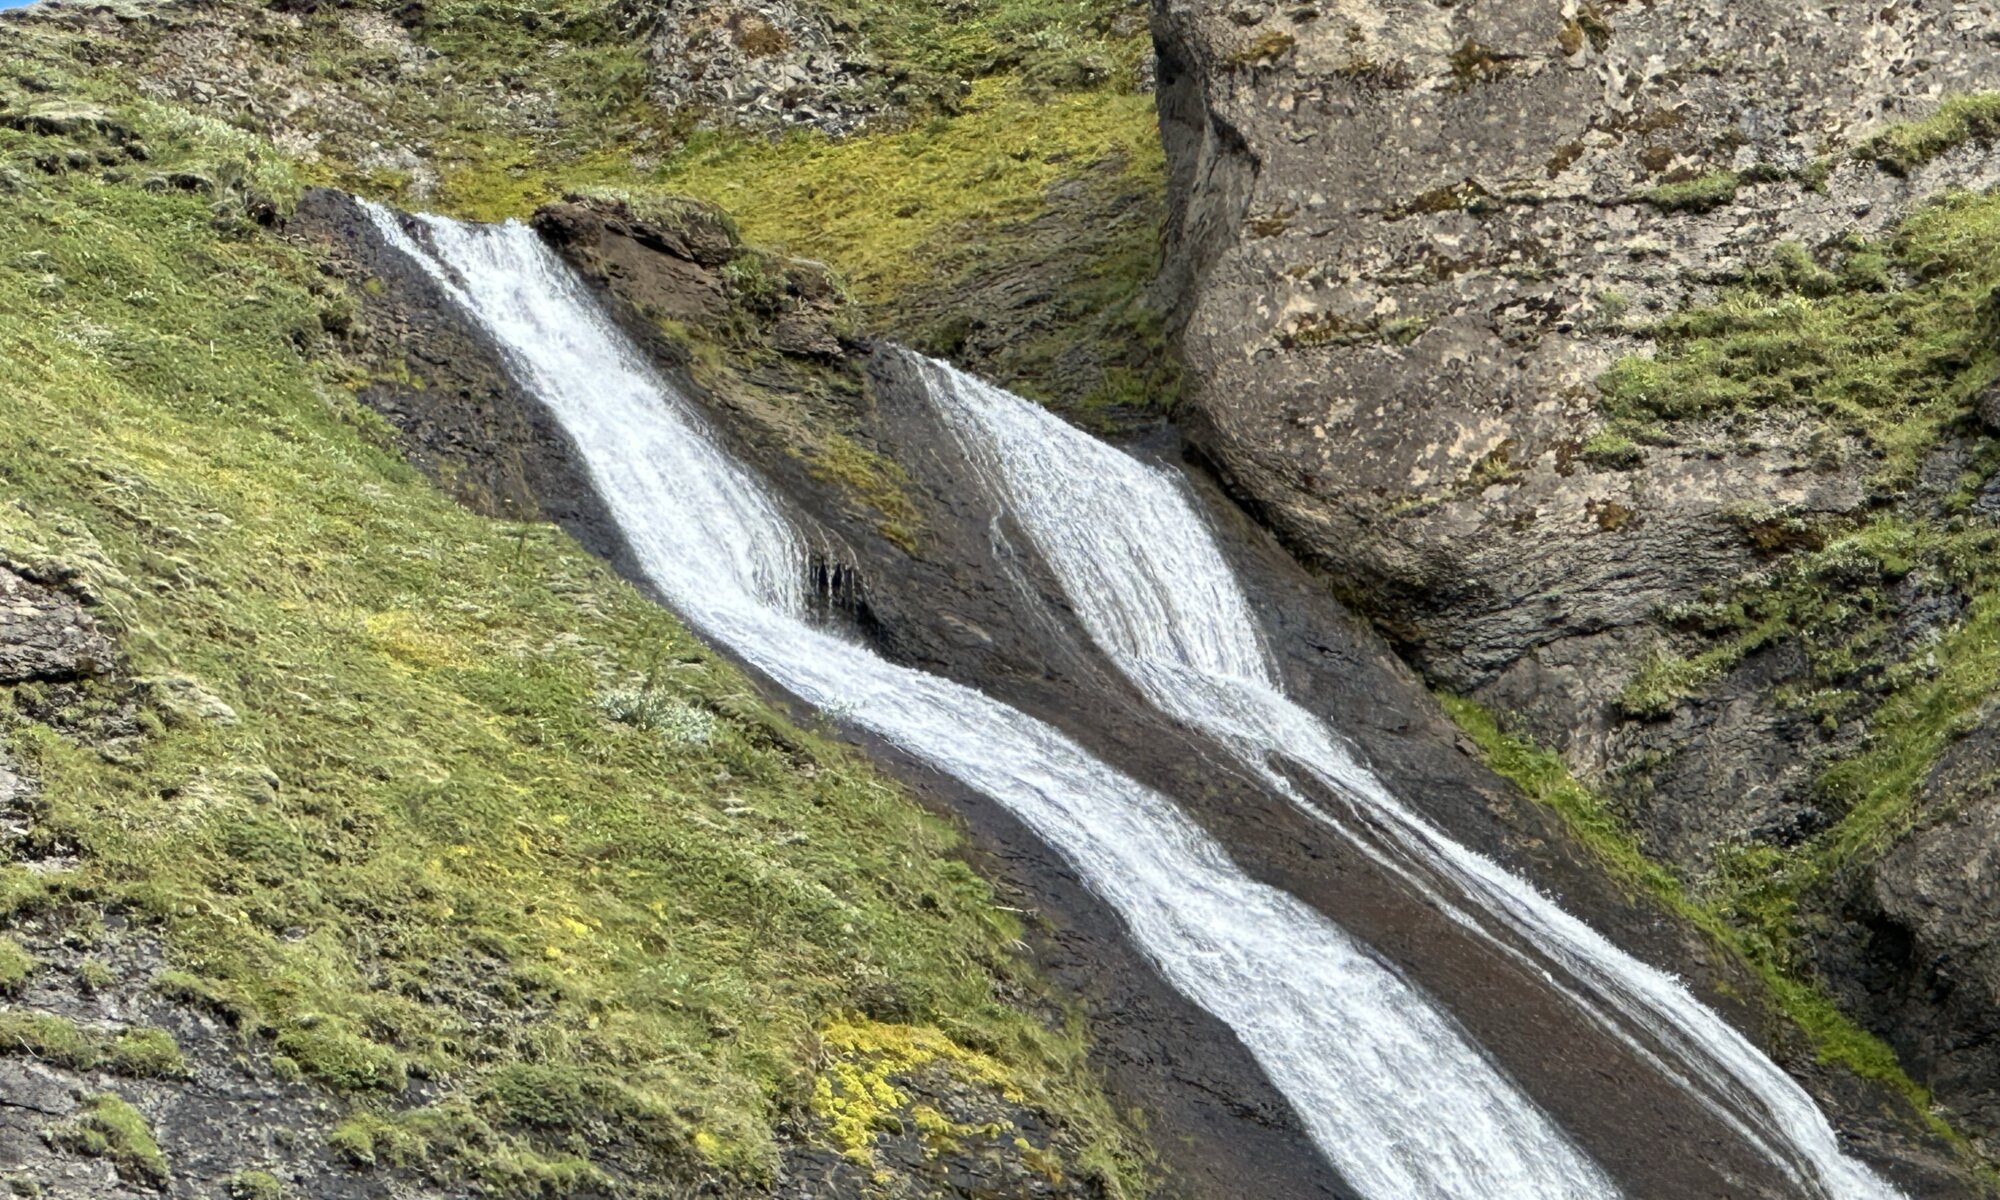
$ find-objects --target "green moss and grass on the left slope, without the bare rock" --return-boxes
[0,91,1138,1192]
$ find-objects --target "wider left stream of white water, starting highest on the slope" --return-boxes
[368,206,1618,1200]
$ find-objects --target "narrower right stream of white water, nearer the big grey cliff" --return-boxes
[910,354,1898,1200]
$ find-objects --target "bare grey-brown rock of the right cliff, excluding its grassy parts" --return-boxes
[1158,0,2000,736]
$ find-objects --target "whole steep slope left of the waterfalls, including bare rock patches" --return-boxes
[0,10,1148,1196]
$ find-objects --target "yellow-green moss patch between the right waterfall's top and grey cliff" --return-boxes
[662,76,1178,422]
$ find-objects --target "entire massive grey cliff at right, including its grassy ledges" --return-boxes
[1156,0,2000,1168]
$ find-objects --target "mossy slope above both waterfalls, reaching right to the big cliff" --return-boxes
[14,0,1178,426]
